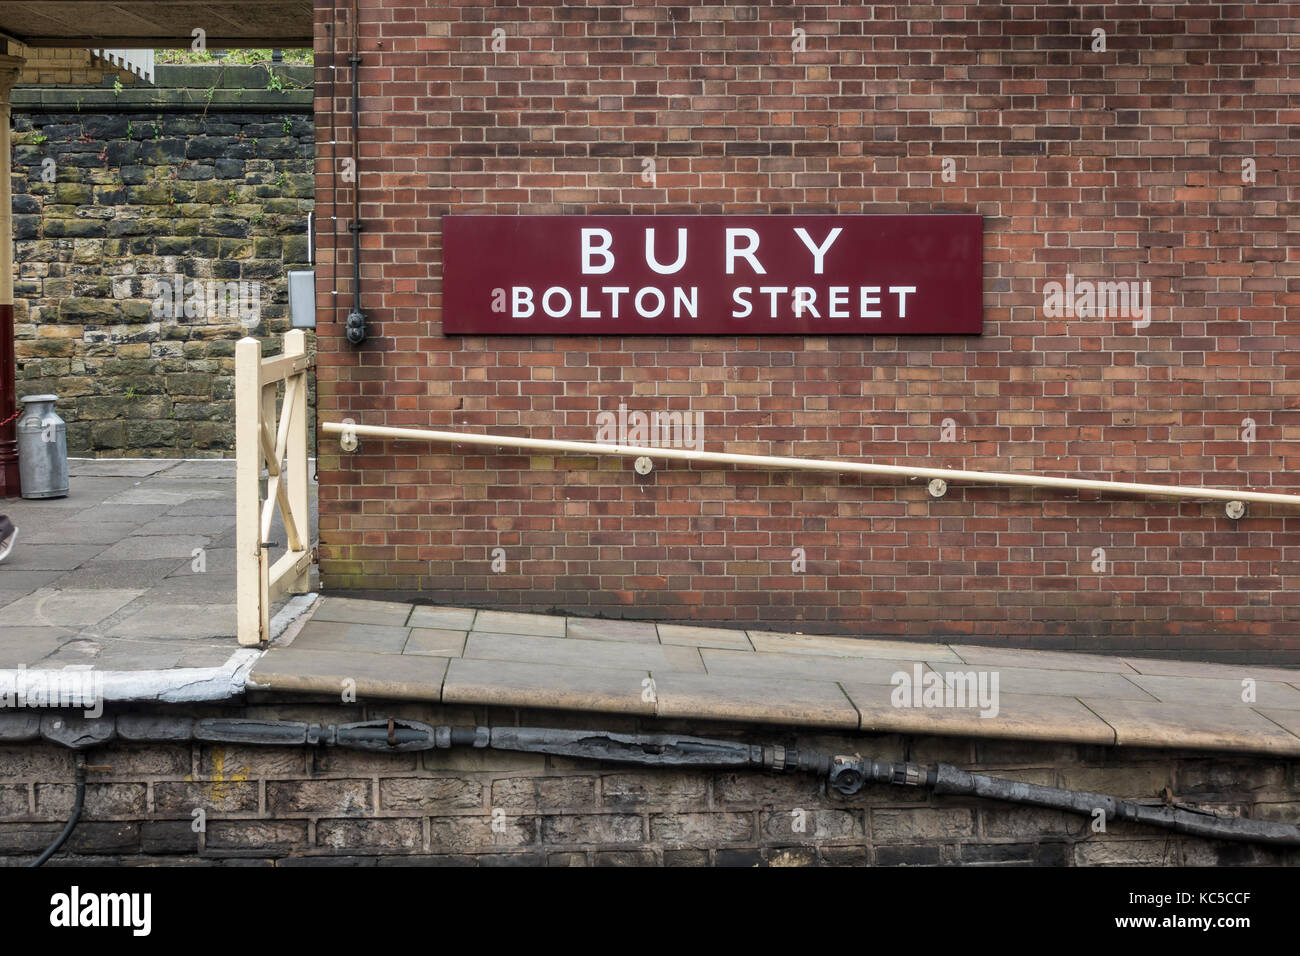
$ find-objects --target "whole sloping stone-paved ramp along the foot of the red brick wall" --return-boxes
[247,597,1300,756]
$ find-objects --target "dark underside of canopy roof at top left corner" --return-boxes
[0,0,312,49]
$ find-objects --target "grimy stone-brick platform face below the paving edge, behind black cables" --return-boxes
[0,704,1300,866]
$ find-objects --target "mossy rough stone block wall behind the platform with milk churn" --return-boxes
[13,65,315,458]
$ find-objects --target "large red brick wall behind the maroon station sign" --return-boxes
[316,0,1300,659]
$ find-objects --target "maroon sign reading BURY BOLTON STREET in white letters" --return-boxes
[442,215,984,336]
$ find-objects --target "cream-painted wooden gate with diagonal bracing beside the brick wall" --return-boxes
[235,329,315,644]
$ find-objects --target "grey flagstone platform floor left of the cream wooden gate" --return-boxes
[0,459,312,671]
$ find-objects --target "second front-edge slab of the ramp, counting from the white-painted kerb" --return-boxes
[444,656,654,714]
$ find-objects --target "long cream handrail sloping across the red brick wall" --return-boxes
[321,421,1300,518]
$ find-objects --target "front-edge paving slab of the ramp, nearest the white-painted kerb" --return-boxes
[250,646,447,701]
